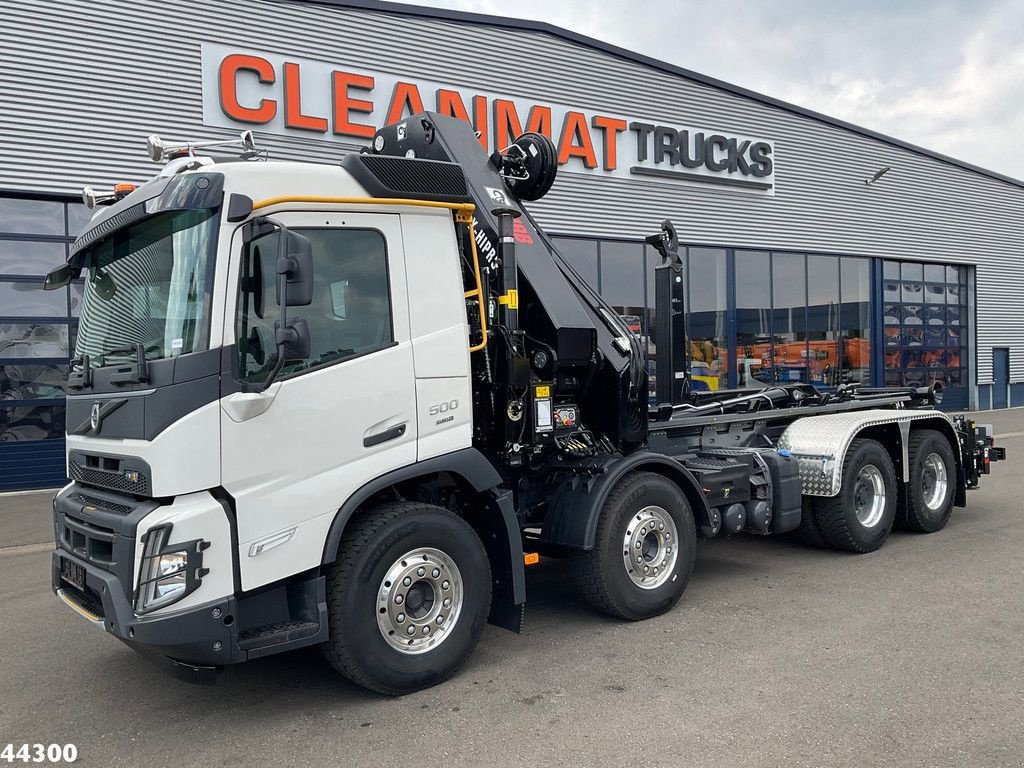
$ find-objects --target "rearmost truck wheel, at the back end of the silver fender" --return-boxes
[903,429,956,534]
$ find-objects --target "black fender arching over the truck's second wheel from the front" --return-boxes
[541,451,711,550]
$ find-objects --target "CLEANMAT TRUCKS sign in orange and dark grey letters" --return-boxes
[202,43,775,195]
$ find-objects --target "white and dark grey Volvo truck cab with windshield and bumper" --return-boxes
[53,144,507,684]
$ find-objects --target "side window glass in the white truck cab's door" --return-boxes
[237,228,394,381]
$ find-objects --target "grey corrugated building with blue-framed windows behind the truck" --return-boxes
[0,0,1024,489]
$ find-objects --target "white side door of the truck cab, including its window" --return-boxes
[221,212,417,590]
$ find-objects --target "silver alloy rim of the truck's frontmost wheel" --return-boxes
[377,547,465,655]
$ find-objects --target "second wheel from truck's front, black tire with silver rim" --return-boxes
[569,472,696,622]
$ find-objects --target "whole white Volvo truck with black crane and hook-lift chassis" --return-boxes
[46,113,1004,694]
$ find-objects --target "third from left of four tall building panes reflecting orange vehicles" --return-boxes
[807,255,840,387]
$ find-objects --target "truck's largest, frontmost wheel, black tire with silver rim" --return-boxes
[324,502,490,695]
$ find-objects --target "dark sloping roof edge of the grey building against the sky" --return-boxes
[284,0,1024,188]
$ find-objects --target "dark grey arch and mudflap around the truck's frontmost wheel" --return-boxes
[321,449,526,632]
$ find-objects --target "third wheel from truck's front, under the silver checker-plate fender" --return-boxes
[811,439,897,553]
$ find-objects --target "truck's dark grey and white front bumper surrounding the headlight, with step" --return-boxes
[50,483,328,683]
